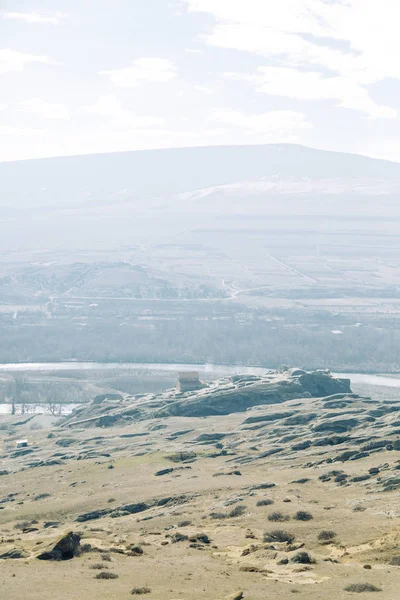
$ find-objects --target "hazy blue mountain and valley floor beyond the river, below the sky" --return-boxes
[0,145,400,372]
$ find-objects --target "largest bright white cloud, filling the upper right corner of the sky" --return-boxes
[185,0,400,117]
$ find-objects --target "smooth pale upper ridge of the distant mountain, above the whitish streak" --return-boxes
[0,144,400,208]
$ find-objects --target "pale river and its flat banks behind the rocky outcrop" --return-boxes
[0,361,400,415]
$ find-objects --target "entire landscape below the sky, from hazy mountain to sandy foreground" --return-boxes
[0,145,400,600]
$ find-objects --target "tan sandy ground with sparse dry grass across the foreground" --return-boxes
[0,400,400,600]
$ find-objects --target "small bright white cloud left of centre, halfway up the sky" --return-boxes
[100,58,176,88]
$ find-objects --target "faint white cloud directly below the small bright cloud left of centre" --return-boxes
[84,94,163,129]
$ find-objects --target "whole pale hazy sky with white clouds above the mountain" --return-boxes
[0,0,400,161]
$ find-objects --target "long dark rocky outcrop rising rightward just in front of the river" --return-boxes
[61,369,351,427]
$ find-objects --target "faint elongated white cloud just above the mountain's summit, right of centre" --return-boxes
[211,110,312,141]
